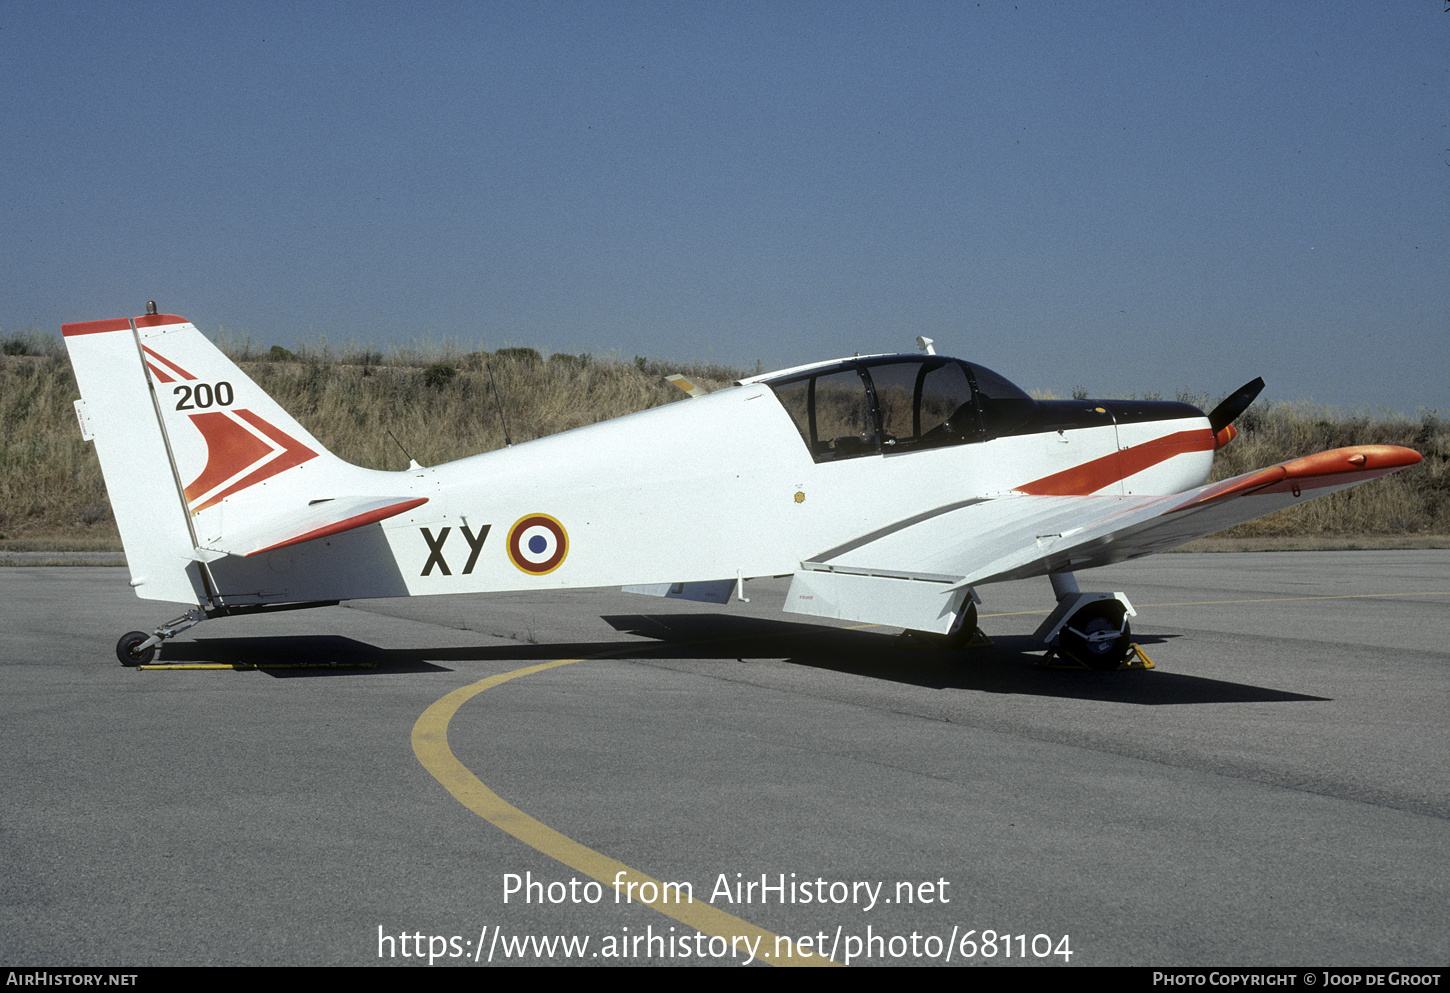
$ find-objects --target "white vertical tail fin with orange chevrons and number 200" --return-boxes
[62,313,367,603]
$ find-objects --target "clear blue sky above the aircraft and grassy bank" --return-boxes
[0,0,1450,413]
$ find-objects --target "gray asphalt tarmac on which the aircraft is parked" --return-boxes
[0,551,1450,967]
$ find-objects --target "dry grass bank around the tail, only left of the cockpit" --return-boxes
[0,333,744,551]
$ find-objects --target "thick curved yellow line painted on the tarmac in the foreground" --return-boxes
[413,647,840,965]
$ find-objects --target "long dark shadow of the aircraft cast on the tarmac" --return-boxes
[161,613,1328,706]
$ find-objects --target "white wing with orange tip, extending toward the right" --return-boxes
[787,445,1421,591]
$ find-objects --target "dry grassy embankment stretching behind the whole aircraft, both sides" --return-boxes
[0,333,1450,551]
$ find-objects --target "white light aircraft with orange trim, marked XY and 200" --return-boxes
[62,306,1420,668]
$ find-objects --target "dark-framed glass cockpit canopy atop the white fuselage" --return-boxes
[764,355,1037,462]
